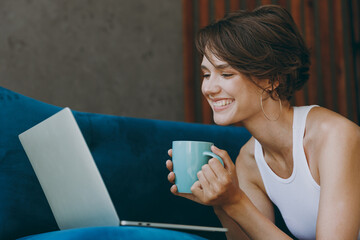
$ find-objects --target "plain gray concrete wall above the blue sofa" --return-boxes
[0,0,184,121]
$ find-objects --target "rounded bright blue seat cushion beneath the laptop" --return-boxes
[19,226,205,240]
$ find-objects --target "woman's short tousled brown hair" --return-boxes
[196,5,310,100]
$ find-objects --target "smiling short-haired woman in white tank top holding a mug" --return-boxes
[166,5,360,240]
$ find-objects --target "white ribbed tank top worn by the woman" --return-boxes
[255,106,320,239]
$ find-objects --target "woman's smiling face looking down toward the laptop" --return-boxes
[201,54,261,125]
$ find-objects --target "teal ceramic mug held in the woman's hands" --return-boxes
[172,141,224,193]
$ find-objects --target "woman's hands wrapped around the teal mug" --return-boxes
[166,146,242,207]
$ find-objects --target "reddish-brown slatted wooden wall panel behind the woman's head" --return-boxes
[183,0,360,123]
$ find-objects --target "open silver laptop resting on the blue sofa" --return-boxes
[19,108,227,232]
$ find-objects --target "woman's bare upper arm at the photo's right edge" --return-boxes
[311,117,360,240]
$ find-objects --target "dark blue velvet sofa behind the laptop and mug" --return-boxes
[0,88,250,240]
